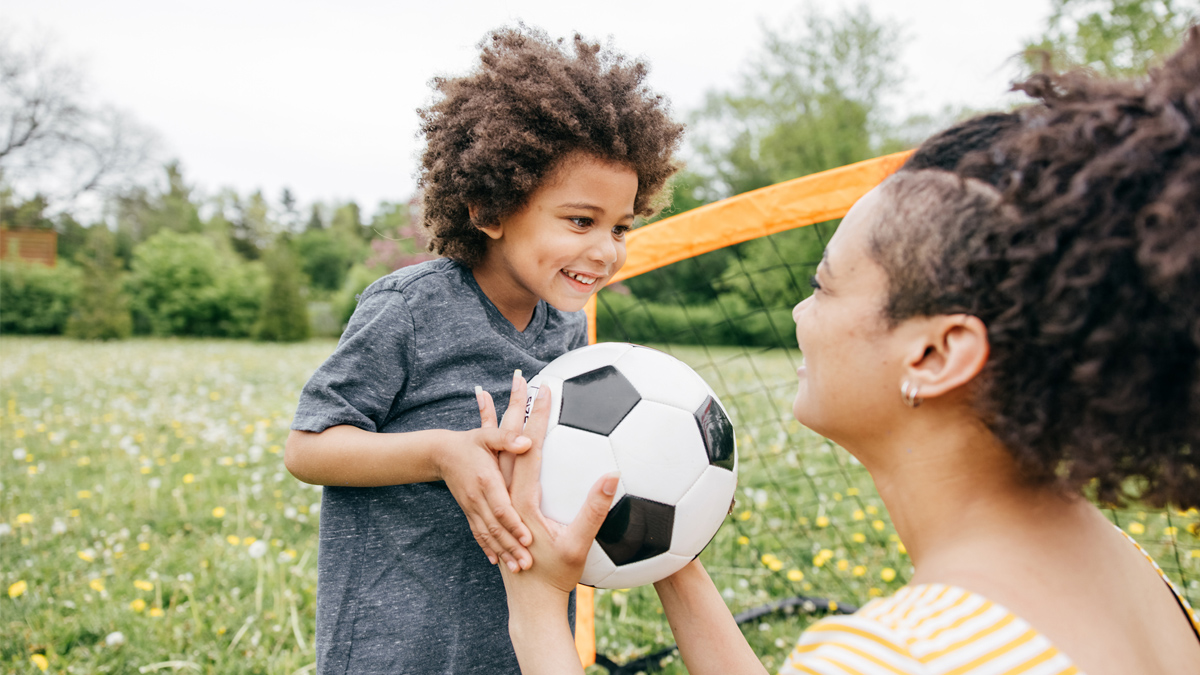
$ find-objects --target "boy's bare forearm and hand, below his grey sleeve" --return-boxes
[283,424,533,569]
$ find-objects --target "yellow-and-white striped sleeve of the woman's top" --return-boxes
[779,615,930,675]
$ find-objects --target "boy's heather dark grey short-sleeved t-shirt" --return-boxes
[292,258,587,675]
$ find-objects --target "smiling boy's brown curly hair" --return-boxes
[419,25,683,265]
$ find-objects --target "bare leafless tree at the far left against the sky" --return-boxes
[0,35,156,210]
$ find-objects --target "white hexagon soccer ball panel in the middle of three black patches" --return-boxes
[608,401,708,504]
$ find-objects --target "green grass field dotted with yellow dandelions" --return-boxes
[0,338,1200,674]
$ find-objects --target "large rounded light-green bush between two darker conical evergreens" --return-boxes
[126,231,266,338]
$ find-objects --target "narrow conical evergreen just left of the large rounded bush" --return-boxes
[66,225,133,340]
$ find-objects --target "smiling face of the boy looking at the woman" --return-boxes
[475,154,637,317]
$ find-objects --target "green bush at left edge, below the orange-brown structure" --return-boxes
[0,259,79,335]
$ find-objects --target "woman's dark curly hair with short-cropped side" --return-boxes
[875,29,1200,507]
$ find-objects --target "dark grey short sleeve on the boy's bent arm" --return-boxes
[292,289,415,432]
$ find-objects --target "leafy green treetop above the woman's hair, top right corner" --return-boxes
[1026,0,1200,77]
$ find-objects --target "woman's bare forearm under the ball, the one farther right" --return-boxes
[654,560,767,675]
